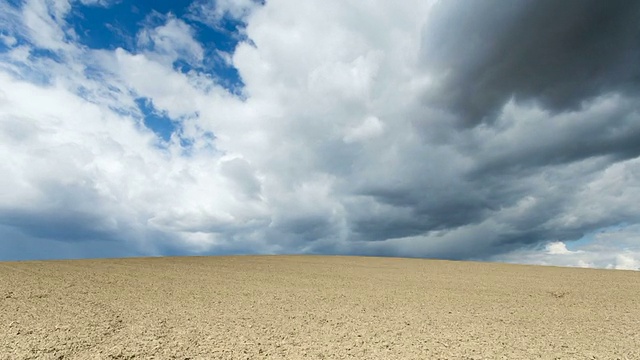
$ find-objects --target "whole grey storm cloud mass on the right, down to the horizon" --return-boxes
[328,0,640,259]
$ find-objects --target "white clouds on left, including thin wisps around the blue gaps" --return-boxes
[0,2,266,253]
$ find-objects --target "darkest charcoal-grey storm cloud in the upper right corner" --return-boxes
[422,0,640,126]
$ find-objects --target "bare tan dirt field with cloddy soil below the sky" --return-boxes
[0,256,640,359]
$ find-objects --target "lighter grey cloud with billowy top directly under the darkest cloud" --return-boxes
[470,94,640,176]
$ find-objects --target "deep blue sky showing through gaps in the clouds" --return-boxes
[65,0,245,141]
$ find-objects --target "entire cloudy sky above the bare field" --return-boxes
[0,0,640,270]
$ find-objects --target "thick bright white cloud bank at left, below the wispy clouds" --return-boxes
[0,67,265,255]
